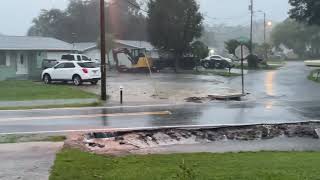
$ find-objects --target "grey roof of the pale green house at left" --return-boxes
[0,36,73,51]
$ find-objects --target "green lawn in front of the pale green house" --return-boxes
[0,81,97,101]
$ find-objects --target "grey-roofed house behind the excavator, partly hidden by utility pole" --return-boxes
[74,40,159,67]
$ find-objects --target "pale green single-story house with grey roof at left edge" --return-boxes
[0,36,73,80]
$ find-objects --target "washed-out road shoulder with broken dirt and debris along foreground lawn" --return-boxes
[65,122,320,155]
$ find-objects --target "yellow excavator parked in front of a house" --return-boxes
[112,48,155,72]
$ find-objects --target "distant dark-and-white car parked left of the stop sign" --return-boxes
[200,55,234,69]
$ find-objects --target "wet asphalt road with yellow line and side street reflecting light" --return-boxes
[0,62,320,134]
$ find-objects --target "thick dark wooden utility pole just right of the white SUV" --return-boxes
[100,0,107,101]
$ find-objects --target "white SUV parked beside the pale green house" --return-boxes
[41,61,101,86]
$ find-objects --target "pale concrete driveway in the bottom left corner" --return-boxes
[0,142,63,180]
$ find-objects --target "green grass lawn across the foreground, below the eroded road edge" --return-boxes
[50,149,320,180]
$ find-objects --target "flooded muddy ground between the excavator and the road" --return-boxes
[80,73,239,103]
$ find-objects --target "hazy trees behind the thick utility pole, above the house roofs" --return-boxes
[28,0,148,42]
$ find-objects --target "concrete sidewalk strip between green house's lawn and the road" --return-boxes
[0,99,98,108]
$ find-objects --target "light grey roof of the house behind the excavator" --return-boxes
[75,40,155,52]
